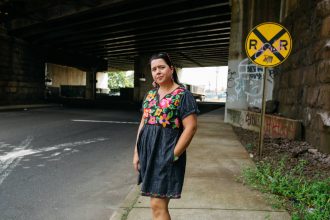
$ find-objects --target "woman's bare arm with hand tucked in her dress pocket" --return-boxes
[174,114,197,157]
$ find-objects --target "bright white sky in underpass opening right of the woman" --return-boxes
[179,66,228,91]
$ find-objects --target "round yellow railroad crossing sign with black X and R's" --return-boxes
[245,22,292,67]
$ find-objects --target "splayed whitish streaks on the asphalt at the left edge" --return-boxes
[0,136,108,185]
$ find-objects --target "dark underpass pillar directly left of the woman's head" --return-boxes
[134,55,153,102]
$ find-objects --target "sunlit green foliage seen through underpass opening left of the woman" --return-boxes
[108,71,134,90]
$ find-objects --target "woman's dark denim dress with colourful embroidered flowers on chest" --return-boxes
[137,86,198,198]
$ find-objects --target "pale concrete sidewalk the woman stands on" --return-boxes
[110,110,291,220]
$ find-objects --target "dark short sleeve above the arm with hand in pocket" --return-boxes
[179,90,199,120]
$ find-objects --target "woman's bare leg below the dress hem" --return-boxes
[150,197,171,220]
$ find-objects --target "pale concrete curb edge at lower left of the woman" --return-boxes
[109,185,140,220]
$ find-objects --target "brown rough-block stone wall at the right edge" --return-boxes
[274,0,330,153]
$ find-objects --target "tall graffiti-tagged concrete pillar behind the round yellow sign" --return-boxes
[225,0,280,118]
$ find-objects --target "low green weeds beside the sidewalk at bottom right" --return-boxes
[242,158,330,220]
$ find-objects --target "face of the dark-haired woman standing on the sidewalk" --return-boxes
[151,58,173,85]
